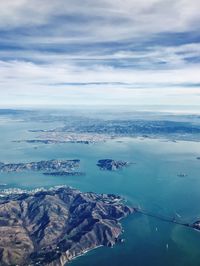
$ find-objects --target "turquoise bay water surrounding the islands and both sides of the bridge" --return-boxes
[0,121,200,266]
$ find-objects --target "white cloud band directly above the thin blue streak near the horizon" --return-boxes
[0,58,200,86]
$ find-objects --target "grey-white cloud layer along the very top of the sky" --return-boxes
[0,0,200,43]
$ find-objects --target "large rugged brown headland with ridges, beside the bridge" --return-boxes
[0,187,134,266]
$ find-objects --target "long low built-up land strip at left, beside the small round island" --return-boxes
[0,159,80,172]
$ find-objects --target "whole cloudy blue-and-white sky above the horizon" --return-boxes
[0,0,200,108]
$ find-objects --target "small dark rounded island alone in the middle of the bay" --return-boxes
[97,159,131,171]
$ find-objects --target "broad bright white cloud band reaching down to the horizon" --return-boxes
[0,58,200,105]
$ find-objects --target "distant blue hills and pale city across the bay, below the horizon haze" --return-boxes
[25,115,200,144]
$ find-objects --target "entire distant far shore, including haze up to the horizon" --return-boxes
[0,109,200,144]
